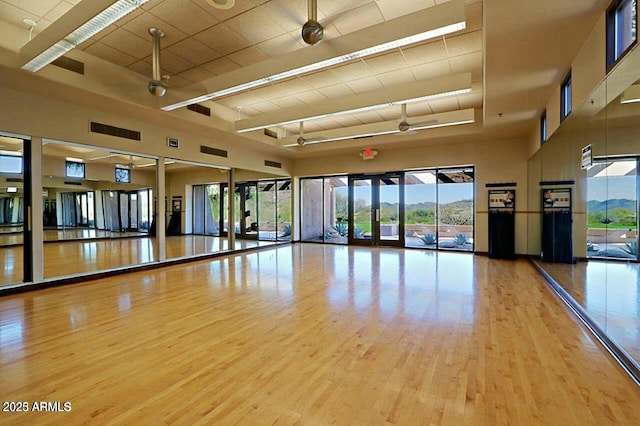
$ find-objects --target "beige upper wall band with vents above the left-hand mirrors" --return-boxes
[0,87,291,176]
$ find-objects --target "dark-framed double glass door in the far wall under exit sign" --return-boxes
[349,173,404,246]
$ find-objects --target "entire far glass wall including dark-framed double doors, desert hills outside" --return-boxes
[300,167,475,251]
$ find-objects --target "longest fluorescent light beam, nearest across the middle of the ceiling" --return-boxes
[162,0,466,111]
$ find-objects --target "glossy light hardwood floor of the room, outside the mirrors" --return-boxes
[0,244,640,425]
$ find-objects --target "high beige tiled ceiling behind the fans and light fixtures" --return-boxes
[0,0,607,158]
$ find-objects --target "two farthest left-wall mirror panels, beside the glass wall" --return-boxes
[165,159,291,258]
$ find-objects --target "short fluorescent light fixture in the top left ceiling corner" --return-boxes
[20,0,149,72]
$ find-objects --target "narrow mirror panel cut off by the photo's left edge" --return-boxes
[0,136,24,286]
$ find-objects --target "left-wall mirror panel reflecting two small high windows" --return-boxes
[42,141,157,278]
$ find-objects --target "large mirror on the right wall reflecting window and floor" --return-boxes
[529,48,640,378]
